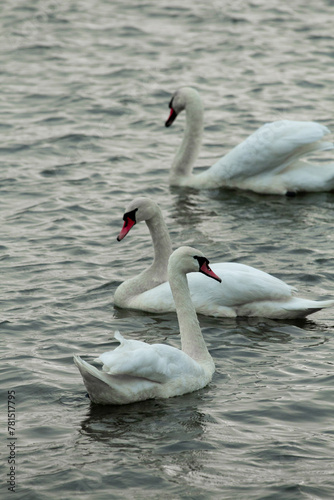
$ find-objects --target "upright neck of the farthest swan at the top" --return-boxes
[170,96,203,185]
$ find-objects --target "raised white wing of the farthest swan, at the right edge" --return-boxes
[211,120,334,179]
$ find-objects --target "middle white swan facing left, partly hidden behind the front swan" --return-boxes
[114,197,334,319]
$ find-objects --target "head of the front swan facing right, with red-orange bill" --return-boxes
[168,247,221,283]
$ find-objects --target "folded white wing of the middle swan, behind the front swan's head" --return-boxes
[188,262,292,307]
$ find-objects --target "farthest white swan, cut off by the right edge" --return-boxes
[165,87,334,195]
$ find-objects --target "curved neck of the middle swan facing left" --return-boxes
[114,211,172,307]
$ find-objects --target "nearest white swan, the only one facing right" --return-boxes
[74,247,221,404]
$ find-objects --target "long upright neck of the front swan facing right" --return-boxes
[169,272,213,365]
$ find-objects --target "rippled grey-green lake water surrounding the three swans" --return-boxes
[0,0,334,500]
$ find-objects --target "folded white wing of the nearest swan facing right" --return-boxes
[97,337,203,383]
